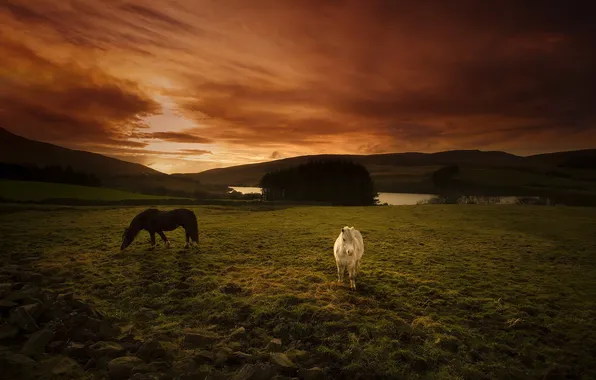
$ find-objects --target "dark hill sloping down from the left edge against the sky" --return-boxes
[0,128,163,178]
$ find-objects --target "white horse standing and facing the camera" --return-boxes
[333,226,364,290]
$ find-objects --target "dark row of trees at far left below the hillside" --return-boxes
[0,163,101,187]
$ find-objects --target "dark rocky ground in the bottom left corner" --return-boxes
[0,259,324,380]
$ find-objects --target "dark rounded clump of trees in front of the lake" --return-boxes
[259,160,377,205]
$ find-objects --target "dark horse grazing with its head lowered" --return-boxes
[120,208,199,250]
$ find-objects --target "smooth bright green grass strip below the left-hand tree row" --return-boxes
[0,180,189,201]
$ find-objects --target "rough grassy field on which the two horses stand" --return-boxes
[0,205,596,379]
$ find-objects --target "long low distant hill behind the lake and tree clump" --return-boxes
[184,150,596,194]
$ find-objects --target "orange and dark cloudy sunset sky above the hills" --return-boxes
[0,0,596,173]
